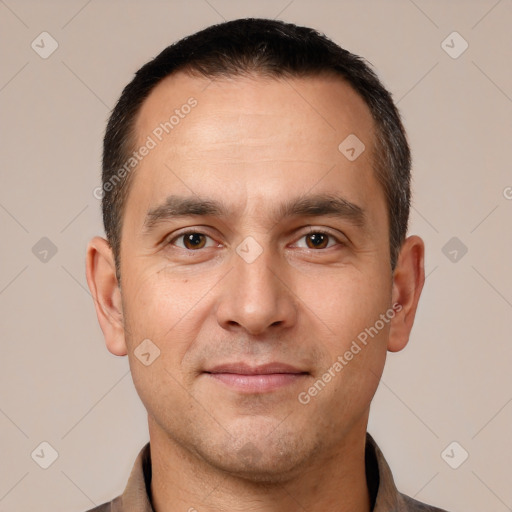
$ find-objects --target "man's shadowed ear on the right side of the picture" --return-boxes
[388,236,425,352]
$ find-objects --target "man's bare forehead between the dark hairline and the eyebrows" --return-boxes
[127,72,384,230]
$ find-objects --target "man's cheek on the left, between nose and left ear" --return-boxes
[123,269,204,418]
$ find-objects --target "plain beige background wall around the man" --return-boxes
[0,0,512,512]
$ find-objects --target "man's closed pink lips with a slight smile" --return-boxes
[204,363,310,393]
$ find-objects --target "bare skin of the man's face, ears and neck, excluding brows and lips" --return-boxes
[87,73,424,512]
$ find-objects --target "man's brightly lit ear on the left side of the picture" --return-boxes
[86,236,127,356]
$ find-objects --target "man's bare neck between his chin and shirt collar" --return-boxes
[149,417,370,512]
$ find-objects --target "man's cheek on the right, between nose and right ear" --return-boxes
[296,269,391,410]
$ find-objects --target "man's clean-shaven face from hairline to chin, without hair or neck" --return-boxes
[90,70,424,479]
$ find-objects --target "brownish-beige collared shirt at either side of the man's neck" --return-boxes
[88,434,446,512]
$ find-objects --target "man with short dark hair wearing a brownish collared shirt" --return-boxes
[87,19,448,512]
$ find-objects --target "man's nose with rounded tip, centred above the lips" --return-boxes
[217,243,297,335]
